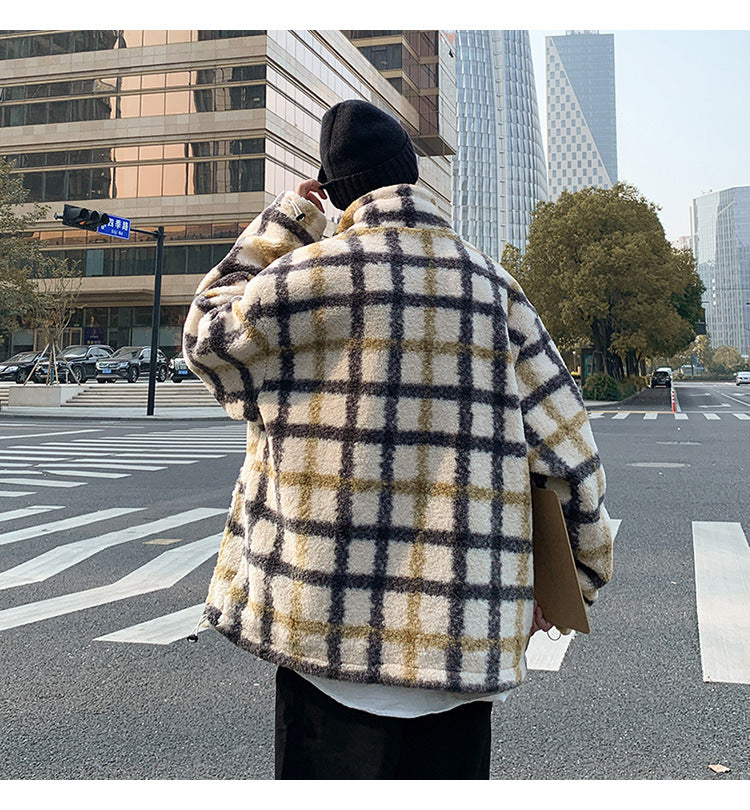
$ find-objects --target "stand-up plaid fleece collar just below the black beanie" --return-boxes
[336,183,450,234]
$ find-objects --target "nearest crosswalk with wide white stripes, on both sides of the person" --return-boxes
[0,504,750,684]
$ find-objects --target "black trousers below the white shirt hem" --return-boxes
[275,667,492,779]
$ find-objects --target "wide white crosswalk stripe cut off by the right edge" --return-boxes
[693,521,750,684]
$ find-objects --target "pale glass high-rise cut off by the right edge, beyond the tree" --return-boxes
[690,186,750,354]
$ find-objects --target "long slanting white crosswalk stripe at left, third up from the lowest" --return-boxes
[0,507,226,590]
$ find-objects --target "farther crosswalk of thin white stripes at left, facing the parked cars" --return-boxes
[0,423,245,504]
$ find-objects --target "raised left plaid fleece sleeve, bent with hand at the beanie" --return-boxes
[183,192,326,423]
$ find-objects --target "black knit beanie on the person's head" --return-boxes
[318,100,419,211]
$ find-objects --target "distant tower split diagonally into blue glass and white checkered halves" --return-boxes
[545,31,617,200]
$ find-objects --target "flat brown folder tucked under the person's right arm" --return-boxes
[531,487,591,633]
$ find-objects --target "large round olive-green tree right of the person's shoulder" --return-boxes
[503,183,703,379]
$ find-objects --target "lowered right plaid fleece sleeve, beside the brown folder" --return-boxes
[508,284,612,604]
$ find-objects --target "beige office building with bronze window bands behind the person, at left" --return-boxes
[0,30,455,358]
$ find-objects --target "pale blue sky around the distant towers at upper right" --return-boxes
[529,29,750,241]
